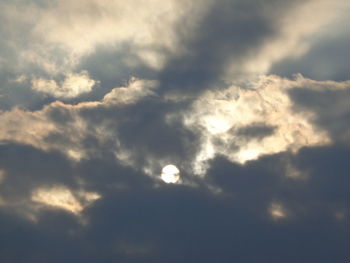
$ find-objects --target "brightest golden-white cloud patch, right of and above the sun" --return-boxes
[184,76,330,174]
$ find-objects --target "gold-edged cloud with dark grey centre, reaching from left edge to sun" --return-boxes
[0,79,192,177]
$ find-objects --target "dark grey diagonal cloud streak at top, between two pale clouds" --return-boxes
[159,0,308,93]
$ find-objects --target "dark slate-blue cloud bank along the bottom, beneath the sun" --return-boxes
[0,146,350,263]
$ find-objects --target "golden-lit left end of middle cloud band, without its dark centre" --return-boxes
[0,79,156,160]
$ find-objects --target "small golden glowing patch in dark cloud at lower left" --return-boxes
[31,186,101,215]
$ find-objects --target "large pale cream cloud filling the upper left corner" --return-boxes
[1,0,204,78]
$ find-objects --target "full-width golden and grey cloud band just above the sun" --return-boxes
[0,75,349,179]
